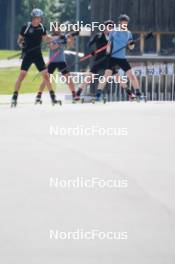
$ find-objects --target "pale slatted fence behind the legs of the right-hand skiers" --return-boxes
[90,63,175,101]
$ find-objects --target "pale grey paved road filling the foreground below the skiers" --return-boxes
[0,95,175,264]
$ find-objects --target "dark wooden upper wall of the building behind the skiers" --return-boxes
[91,0,175,32]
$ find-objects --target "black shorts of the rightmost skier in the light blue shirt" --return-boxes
[107,58,131,72]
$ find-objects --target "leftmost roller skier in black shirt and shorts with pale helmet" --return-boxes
[11,8,57,106]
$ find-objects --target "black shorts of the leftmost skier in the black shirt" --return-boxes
[21,52,46,72]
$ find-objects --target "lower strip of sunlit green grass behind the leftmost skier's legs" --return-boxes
[0,66,68,94]
